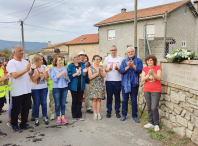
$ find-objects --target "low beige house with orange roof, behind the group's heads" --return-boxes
[43,34,99,60]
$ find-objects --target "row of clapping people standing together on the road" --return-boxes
[0,45,162,131]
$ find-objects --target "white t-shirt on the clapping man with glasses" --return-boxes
[103,55,123,81]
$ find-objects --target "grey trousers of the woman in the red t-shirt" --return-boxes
[144,92,161,125]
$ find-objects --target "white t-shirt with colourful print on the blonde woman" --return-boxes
[31,65,47,89]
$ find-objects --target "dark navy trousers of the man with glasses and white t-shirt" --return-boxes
[106,81,121,112]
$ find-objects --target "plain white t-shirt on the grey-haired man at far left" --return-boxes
[6,59,31,96]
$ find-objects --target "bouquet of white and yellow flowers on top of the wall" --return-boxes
[166,49,197,62]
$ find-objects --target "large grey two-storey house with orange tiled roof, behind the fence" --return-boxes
[94,0,198,59]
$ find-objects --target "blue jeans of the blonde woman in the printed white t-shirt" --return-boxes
[32,88,48,119]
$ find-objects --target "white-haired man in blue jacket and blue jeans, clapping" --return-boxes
[120,47,143,123]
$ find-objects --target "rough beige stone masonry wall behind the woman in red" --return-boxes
[138,81,198,145]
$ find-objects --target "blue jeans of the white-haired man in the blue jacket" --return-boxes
[122,86,139,118]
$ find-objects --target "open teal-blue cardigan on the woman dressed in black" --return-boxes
[67,63,88,91]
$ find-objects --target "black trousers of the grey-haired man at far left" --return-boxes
[11,93,31,128]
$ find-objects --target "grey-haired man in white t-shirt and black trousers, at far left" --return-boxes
[7,45,33,132]
